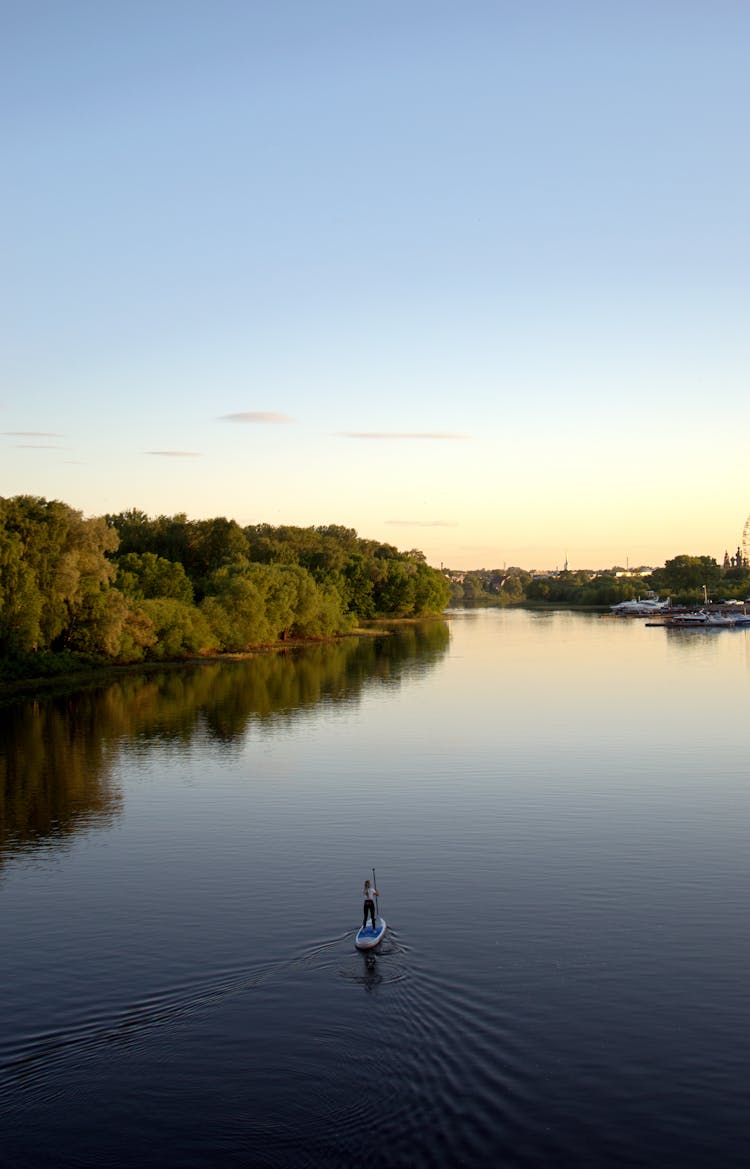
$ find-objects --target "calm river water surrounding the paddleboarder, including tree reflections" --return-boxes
[0,610,750,1169]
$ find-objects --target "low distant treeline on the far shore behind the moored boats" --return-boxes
[446,549,750,607]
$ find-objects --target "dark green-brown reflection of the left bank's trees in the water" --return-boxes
[0,621,450,863]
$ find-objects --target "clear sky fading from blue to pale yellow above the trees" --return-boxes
[0,0,750,569]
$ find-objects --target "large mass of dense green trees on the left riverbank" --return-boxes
[0,496,451,678]
